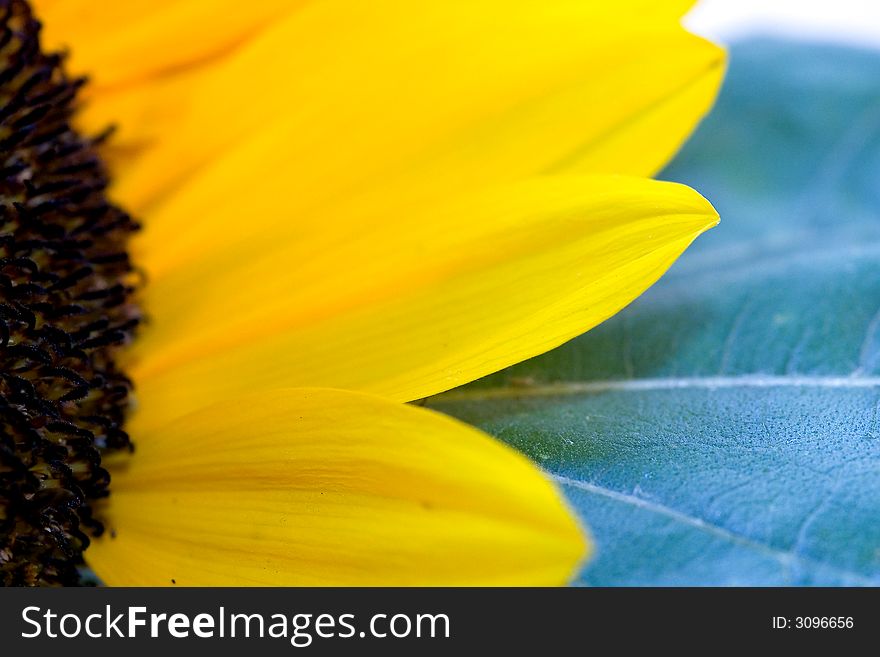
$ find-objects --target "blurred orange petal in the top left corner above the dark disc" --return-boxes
[32,0,305,89]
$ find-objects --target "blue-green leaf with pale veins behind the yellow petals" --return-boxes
[429,41,880,585]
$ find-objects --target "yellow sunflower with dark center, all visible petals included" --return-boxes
[0,0,724,585]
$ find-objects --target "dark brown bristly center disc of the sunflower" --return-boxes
[0,0,140,585]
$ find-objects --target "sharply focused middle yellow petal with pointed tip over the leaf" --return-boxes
[129,177,717,426]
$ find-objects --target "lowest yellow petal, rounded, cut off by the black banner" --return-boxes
[86,390,586,586]
